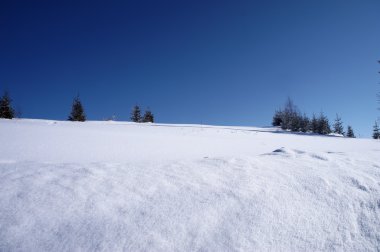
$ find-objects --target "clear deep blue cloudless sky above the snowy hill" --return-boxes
[0,0,380,136]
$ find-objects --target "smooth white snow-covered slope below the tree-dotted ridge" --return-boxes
[0,120,380,251]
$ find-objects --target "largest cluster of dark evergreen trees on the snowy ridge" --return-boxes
[272,98,355,137]
